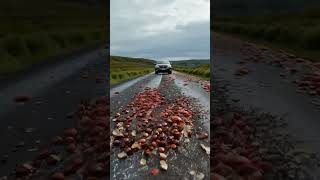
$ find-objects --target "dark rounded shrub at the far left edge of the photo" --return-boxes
[1,35,29,57]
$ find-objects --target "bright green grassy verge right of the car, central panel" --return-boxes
[174,64,210,80]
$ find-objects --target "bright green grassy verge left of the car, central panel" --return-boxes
[110,56,154,86]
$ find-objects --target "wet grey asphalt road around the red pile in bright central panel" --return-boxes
[110,72,210,179]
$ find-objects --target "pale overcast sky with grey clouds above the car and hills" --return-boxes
[110,0,210,60]
